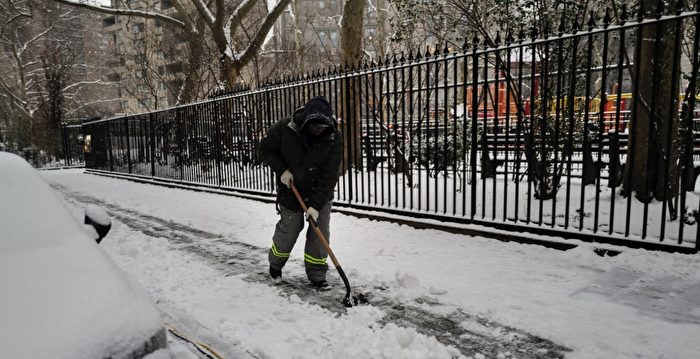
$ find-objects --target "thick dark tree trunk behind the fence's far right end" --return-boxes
[624,0,680,202]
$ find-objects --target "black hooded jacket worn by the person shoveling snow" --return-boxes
[259,107,343,211]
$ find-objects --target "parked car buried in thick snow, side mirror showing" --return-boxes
[0,152,171,359]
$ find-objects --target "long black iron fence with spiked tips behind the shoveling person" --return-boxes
[76,5,700,252]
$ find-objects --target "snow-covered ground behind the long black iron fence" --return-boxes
[105,158,700,247]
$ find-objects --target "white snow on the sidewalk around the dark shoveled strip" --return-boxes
[41,170,700,359]
